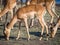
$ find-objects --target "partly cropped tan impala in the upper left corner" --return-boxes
[0,0,16,18]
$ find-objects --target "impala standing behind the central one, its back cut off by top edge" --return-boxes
[27,0,57,26]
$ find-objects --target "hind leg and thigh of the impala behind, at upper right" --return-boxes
[46,2,57,23]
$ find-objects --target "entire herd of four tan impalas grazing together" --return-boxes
[0,0,60,40]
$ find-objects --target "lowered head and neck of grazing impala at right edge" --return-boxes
[50,17,60,38]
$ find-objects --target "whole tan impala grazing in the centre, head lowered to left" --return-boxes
[4,4,48,40]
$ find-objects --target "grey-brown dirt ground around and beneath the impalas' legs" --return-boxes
[0,6,60,45]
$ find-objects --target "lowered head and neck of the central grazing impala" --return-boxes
[3,15,17,40]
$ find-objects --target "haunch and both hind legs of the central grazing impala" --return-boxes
[38,10,48,40]
